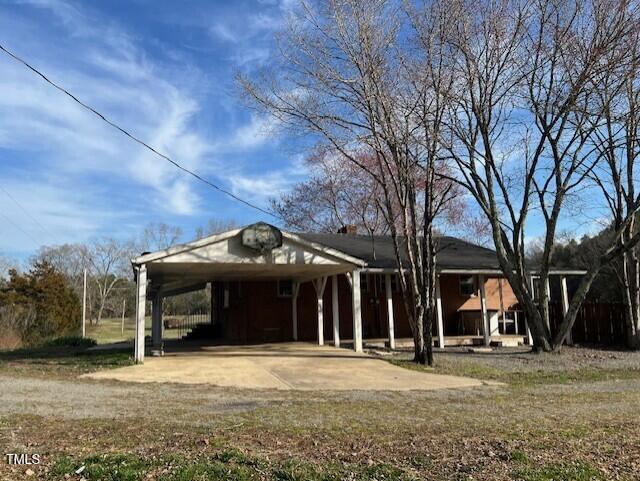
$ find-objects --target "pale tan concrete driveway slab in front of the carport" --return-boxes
[82,343,484,391]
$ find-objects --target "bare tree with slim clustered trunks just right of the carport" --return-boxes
[239,0,460,364]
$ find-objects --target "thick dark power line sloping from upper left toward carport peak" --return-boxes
[0,44,279,219]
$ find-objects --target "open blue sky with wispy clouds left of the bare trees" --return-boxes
[0,0,305,258]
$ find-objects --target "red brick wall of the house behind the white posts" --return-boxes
[220,274,517,343]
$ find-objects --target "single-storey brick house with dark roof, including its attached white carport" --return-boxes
[132,223,581,362]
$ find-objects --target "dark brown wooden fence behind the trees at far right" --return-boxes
[549,302,626,346]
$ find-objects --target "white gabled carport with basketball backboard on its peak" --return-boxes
[132,223,365,363]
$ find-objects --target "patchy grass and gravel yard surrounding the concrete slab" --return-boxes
[0,348,640,481]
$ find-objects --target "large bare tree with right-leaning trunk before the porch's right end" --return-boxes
[443,0,637,350]
